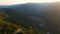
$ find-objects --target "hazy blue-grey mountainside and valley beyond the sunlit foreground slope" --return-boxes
[0,3,60,34]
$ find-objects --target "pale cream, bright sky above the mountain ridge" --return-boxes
[0,0,60,5]
